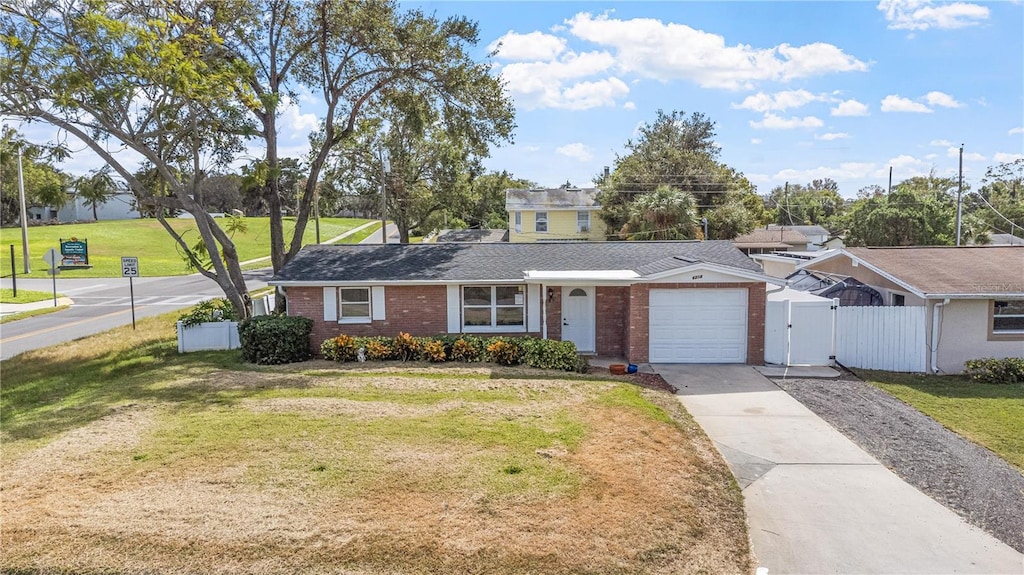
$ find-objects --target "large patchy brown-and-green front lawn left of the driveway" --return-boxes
[0,316,752,573]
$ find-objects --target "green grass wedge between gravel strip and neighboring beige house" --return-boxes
[857,369,1024,470]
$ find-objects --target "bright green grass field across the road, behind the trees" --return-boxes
[0,218,370,277]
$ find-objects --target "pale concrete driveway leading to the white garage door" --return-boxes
[653,364,1024,575]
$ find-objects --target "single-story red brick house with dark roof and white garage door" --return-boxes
[268,241,779,365]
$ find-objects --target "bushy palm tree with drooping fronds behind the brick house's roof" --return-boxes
[620,185,699,239]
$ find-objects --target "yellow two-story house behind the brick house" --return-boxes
[505,187,607,242]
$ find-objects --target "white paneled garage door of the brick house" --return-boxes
[649,290,746,363]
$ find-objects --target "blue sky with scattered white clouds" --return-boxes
[9,0,1024,196]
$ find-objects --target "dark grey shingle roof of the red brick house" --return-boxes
[270,240,761,282]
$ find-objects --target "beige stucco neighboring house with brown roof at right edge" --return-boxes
[804,247,1024,373]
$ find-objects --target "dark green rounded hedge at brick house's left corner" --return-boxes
[239,315,313,365]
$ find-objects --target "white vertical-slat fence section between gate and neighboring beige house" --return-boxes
[839,306,928,372]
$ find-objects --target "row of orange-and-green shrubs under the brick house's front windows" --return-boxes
[321,333,590,373]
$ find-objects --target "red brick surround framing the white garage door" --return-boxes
[627,282,765,365]
